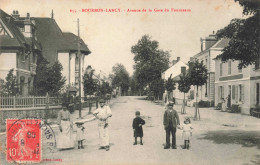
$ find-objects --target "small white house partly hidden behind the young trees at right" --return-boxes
[162,57,189,104]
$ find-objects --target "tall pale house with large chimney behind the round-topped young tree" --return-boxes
[190,32,229,105]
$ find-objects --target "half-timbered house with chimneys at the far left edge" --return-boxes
[0,9,41,95]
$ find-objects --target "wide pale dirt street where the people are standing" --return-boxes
[39,96,260,164]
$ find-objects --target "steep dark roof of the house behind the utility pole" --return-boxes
[32,17,91,62]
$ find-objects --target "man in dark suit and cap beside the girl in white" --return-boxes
[163,102,180,149]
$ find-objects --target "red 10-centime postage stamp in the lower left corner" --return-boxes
[6,119,42,163]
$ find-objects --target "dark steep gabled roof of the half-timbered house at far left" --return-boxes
[0,9,27,47]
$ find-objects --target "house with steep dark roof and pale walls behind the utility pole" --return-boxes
[33,12,91,97]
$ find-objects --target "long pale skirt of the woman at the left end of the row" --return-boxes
[57,120,74,149]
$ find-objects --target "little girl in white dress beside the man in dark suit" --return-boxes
[181,117,193,149]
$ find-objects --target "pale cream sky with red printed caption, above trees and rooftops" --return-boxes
[0,0,243,75]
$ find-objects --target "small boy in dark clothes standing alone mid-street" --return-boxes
[133,111,145,145]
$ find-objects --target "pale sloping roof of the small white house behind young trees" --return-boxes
[162,61,189,80]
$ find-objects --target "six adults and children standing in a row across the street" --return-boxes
[57,99,193,151]
